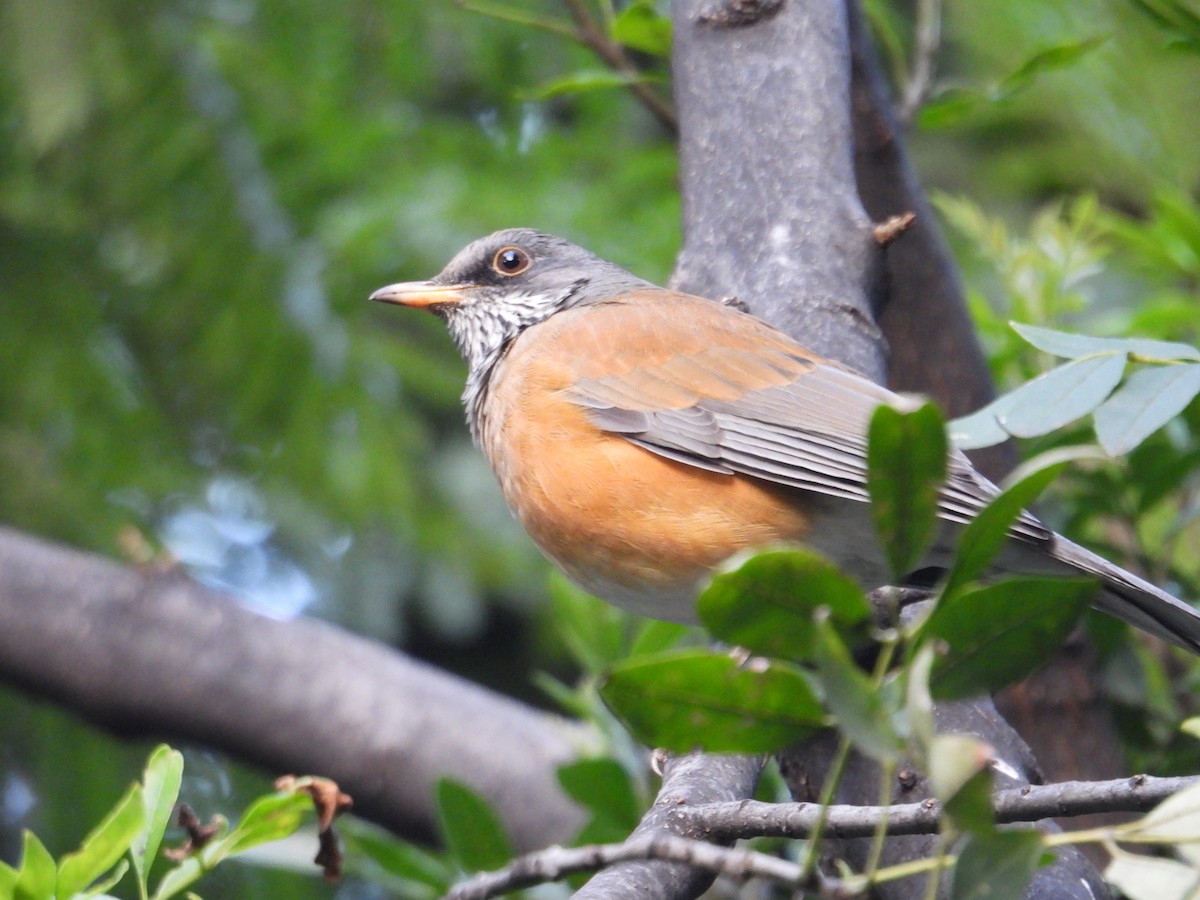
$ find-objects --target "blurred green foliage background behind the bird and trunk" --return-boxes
[0,0,1200,896]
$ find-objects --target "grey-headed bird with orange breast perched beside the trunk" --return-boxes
[370,228,1200,653]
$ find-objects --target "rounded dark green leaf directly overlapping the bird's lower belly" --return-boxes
[696,547,871,660]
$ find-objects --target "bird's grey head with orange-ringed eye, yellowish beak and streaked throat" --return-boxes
[371,228,653,437]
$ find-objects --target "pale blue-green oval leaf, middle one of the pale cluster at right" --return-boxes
[998,353,1128,438]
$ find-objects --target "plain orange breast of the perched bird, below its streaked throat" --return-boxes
[481,300,809,620]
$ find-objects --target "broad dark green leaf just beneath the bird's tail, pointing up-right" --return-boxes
[920,576,1097,700]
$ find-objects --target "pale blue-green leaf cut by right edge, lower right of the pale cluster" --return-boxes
[1094,364,1200,456]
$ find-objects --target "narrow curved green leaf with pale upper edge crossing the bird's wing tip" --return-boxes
[942,448,1090,595]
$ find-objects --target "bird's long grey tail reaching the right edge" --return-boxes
[1049,534,1200,654]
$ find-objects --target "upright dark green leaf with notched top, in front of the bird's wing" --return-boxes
[866,403,947,584]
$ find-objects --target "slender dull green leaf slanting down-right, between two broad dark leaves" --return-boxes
[815,617,902,762]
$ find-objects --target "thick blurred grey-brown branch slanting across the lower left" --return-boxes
[0,528,589,850]
